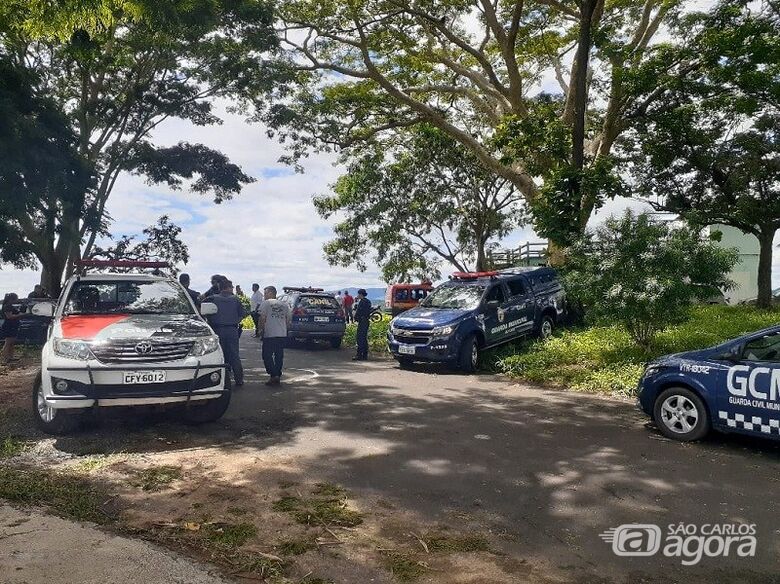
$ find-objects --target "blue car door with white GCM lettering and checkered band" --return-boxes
[713,331,780,436]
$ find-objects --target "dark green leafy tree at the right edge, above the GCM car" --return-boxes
[631,0,780,308]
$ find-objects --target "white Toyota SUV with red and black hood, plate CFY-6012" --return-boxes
[32,274,230,434]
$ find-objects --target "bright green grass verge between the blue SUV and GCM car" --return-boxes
[483,306,780,397]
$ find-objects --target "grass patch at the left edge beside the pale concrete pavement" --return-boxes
[0,466,113,524]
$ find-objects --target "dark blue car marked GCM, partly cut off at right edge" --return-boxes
[639,326,780,442]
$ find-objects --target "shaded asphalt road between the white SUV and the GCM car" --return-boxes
[12,337,780,584]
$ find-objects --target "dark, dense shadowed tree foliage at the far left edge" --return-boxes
[0,57,94,292]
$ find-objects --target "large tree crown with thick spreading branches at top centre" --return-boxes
[264,0,680,244]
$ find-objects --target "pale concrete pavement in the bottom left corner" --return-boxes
[0,505,226,584]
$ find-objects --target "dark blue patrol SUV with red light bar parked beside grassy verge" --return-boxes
[387,267,564,373]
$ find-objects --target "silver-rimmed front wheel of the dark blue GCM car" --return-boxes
[653,387,710,442]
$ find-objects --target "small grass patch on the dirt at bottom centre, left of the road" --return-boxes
[272,483,363,527]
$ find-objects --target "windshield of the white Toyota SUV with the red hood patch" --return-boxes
[63,280,193,315]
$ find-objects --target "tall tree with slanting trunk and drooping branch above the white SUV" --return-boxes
[0,0,276,289]
